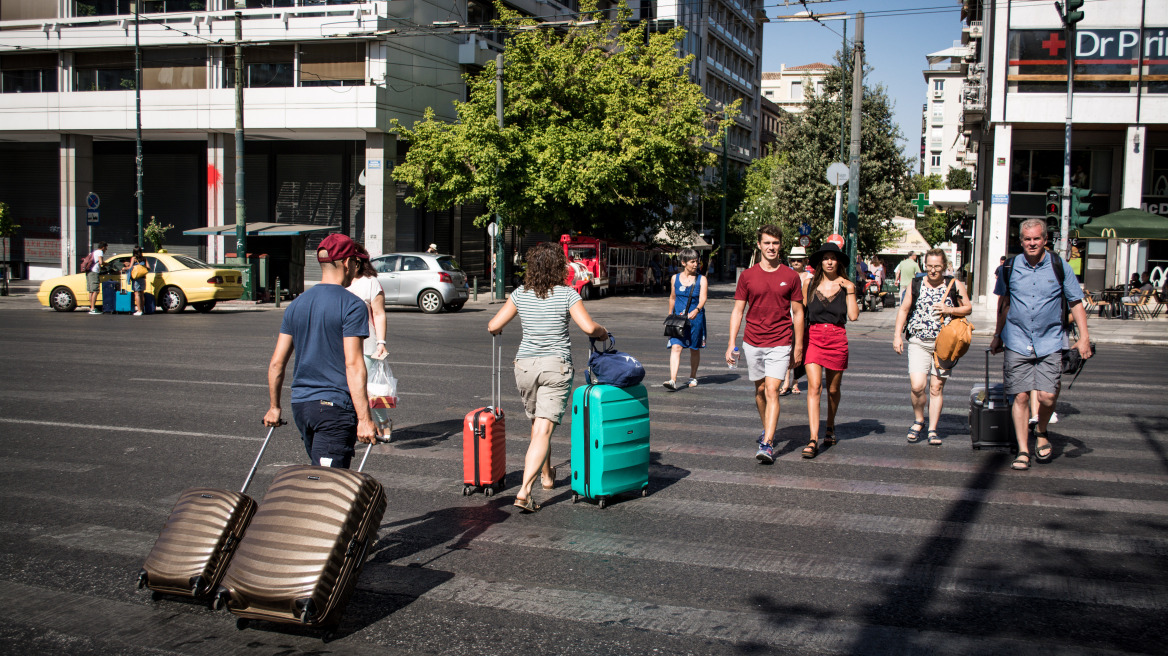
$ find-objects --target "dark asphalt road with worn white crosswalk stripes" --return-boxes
[0,291,1168,656]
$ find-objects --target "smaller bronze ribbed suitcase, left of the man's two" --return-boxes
[138,420,276,596]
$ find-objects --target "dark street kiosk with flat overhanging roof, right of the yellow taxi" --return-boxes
[182,222,341,299]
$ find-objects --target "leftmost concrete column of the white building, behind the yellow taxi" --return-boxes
[60,134,91,274]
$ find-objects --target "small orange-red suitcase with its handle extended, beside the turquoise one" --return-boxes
[463,337,507,496]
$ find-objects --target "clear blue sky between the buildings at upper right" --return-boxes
[763,0,961,168]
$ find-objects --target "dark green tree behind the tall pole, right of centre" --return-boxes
[734,50,911,254]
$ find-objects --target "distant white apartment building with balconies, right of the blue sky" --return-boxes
[920,43,978,177]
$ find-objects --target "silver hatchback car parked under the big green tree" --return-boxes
[371,253,468,314]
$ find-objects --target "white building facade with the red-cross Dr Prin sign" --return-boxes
[962,0,1168,306]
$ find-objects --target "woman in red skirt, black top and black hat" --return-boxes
[802,236,860,458]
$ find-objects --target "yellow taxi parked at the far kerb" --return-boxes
[36,253,243,312]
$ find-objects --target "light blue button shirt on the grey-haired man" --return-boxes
[994,252,1083,357]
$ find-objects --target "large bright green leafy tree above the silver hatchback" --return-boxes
[394,1,719,237]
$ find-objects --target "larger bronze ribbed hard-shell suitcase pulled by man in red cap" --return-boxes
[214,445,385,638]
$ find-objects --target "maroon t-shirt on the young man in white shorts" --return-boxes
[734,264,802,348]
